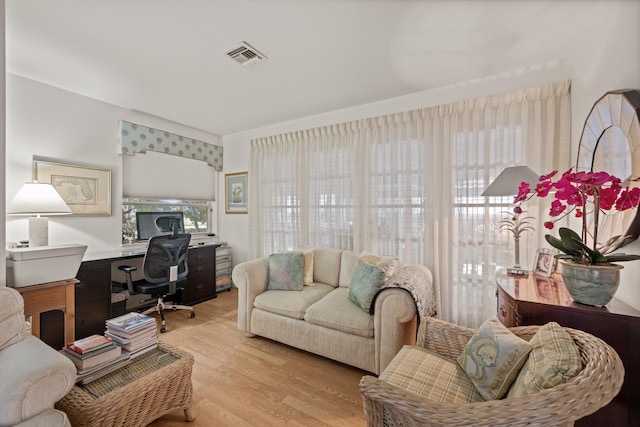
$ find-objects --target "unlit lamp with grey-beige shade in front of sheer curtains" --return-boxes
[481,165,540,274]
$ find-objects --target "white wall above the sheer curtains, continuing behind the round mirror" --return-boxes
[219,1,640,309]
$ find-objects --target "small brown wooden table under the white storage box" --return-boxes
[15,279,78,343]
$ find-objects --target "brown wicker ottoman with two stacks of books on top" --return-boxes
[56,343,195,427]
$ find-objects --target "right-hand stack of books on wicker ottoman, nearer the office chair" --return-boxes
[104,313,158,359]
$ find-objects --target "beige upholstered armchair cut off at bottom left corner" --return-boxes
[0,287,76,427]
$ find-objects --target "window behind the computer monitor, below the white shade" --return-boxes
[122,197,213,243]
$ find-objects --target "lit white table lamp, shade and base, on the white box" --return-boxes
[7,181,72,247]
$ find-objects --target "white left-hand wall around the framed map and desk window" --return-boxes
[2,74,221,259]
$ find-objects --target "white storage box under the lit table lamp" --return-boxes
[7,245,87,288]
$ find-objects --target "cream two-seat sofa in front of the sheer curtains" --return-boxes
[232,248,435,374]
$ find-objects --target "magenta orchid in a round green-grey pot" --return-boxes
[514,169,640,306]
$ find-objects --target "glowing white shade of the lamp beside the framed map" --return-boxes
[7,181,72,216]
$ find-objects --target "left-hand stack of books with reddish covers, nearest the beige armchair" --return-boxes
[61,334,129,384]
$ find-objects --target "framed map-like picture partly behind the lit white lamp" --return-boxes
[33,160,111,216]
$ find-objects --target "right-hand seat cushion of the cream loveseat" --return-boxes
[304,287,373,338]
